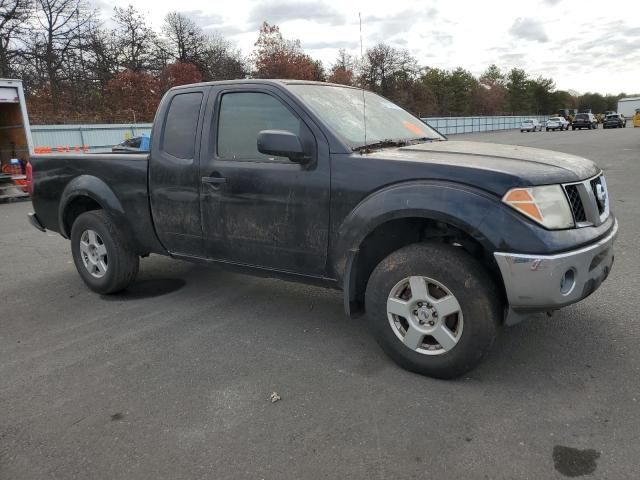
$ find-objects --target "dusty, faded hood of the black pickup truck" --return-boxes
[368,140,600,195]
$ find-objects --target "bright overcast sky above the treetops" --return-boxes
[97,0,640,94]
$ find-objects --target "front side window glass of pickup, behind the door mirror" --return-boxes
[218,92,302,160]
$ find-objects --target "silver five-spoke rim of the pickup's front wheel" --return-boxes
[387,276,464,355]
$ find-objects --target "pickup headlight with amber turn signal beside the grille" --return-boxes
[502,185,575,230]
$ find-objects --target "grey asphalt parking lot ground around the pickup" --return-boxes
[0,128,640,480]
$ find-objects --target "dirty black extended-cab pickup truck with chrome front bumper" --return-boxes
[30,80,618,378]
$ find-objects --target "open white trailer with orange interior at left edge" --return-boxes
[0,78,33,200]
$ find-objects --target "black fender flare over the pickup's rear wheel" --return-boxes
[58,175,129,238]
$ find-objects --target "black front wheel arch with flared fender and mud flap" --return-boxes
[333,182,504,316]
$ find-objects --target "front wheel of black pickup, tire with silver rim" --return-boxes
[365,243,503,378]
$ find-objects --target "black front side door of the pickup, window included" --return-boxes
[200,85,330,276]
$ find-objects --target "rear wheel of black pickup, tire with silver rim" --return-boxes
[71,210,140,294]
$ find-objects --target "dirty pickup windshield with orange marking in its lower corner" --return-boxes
[289,84,444,150]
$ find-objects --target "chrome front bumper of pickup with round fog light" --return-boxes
[494,220,618,324]
